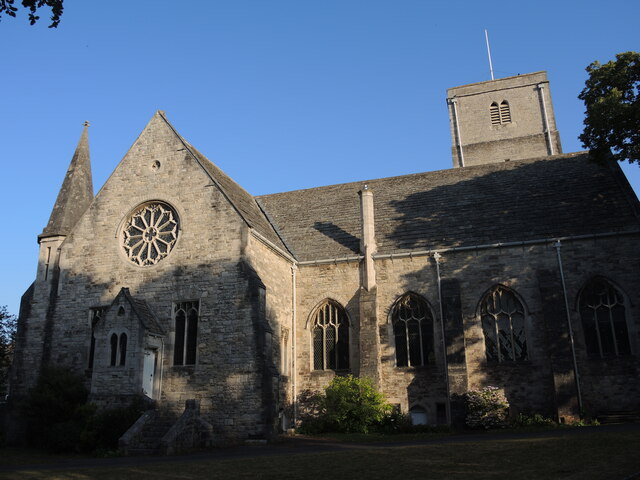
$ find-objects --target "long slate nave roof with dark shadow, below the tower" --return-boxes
[258,152,640,261]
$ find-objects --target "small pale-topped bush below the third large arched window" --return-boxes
[463,387,509,430]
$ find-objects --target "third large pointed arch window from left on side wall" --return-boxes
[480,285,528,363]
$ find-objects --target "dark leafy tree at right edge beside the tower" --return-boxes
[578,52,640,162]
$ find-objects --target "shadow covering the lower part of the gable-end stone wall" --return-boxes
[10,260,279,439]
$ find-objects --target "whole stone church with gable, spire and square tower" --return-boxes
[11,72,640,445]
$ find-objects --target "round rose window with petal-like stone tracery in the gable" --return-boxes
[122,202,178,267]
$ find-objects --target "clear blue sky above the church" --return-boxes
[0,0,640,313]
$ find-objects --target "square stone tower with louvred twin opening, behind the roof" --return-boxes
[447,72,562,167]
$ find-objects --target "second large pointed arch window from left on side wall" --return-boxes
[391,293,434,367]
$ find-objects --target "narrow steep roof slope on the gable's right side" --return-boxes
[157,112,287,251]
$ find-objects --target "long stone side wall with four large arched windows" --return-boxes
[298,232,640,423]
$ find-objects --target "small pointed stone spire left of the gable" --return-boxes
[38,121,93,239]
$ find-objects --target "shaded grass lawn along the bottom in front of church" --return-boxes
[0,429,640,480]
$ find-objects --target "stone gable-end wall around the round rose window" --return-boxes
[26,117,276,437]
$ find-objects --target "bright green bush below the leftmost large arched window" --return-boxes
[301,375,391,433]
